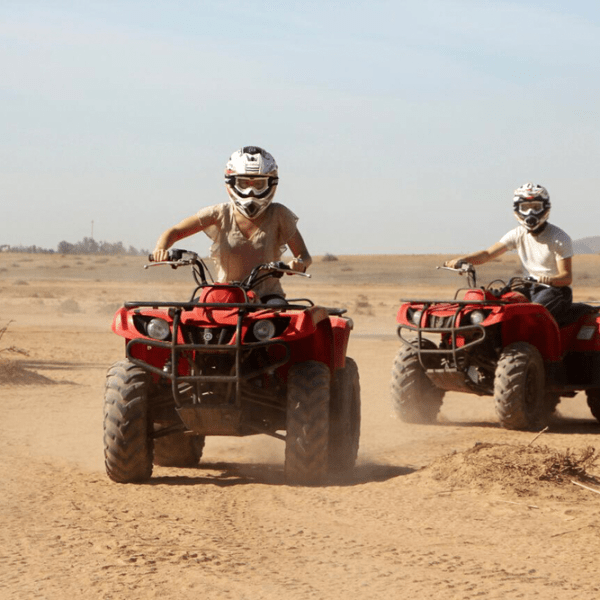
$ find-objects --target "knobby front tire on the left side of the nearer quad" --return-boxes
[104,360,152,483]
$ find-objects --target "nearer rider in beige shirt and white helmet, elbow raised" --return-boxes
[152,146,312,300]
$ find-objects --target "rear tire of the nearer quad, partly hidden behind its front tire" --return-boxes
[329,357,360,473]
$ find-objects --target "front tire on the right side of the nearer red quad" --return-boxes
[285,361,331,485]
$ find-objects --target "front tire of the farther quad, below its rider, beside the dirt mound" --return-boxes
[494,342,555,431]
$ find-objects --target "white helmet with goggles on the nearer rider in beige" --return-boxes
[225,146,279,219]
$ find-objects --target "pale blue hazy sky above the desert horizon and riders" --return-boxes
[0,0,600,254]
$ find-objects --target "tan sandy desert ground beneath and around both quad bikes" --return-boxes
[0,254,600,600]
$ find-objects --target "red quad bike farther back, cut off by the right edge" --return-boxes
[391,263,600,430]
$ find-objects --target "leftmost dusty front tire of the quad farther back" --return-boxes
[391,338,445,423]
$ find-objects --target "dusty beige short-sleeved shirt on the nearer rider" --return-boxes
[197,202,298,296]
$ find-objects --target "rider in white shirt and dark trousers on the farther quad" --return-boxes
[445,183,573,324]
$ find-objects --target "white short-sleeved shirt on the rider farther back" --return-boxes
[500,223,573,278]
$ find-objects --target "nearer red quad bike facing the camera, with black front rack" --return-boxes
[104,249,360,485]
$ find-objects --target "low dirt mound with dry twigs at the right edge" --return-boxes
[419,443,600,496]
